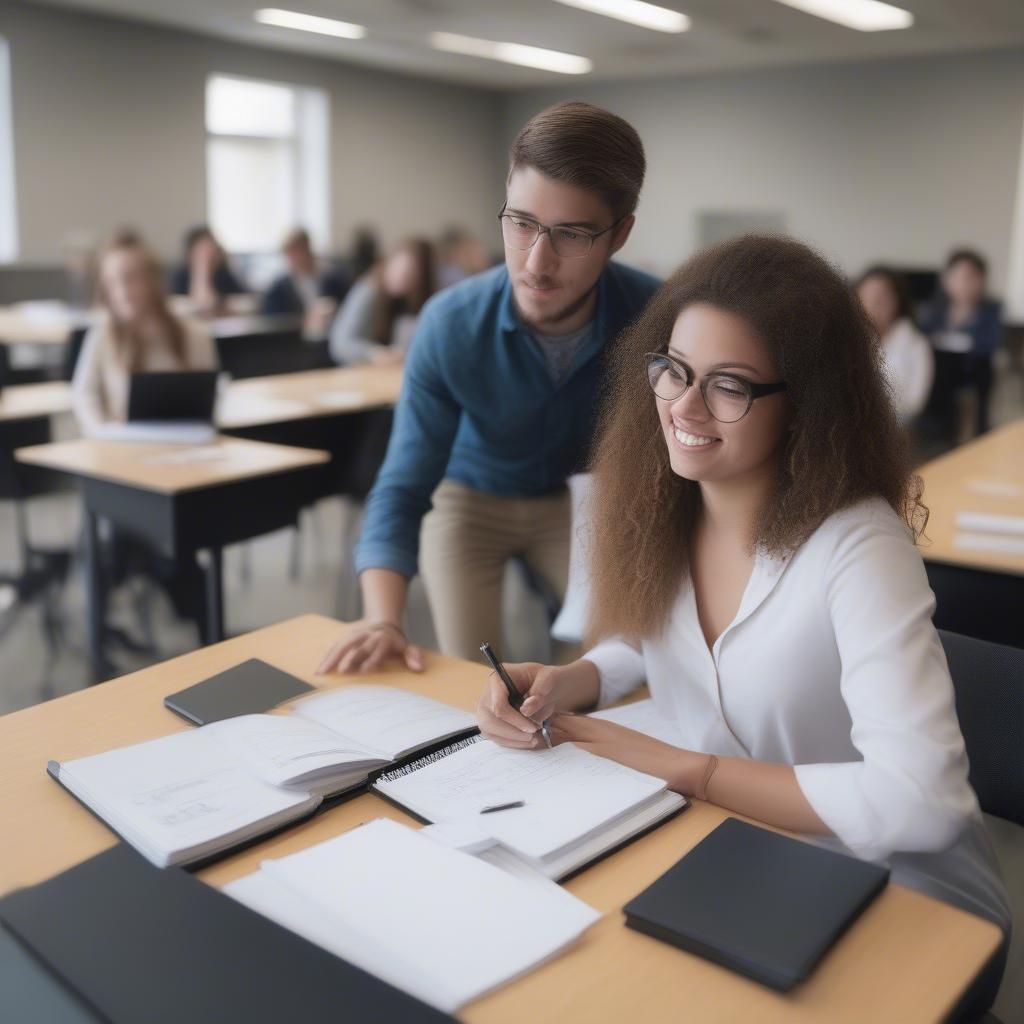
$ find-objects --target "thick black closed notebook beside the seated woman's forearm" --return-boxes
[623,818,889,990]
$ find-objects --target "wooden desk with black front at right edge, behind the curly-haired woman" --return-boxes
[918,420,1024,647]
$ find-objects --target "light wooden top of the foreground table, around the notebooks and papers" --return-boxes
[0,615,1001,1024]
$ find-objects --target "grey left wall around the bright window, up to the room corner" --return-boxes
[0,0,503,263]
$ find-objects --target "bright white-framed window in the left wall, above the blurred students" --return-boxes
[206,75,331,253]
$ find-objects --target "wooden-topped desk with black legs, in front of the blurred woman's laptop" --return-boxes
[15,437,329,679]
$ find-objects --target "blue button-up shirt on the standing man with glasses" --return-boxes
[355,263,658,577]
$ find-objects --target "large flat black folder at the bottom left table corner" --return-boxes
[0,844,452,1024]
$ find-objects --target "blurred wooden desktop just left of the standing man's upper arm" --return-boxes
[217,367,401,430]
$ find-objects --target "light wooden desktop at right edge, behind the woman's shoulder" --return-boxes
[919,420,1024,575]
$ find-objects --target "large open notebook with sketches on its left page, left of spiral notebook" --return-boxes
[48,686,476,867]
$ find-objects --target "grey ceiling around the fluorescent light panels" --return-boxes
[24,0,1024,89]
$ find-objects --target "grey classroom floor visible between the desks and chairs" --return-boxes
[0,354,1024,1024]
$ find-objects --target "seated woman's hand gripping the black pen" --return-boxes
[476,659,600,750]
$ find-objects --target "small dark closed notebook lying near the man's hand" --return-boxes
[164,657,316,725]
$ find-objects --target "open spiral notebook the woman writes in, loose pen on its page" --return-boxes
[372,735,687,879]
